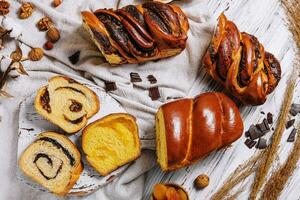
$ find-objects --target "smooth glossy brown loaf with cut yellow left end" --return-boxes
[156,92,244,171]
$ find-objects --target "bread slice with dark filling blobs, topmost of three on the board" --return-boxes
[34,76,99,134]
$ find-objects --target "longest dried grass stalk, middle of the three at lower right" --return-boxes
[249,73,296,200]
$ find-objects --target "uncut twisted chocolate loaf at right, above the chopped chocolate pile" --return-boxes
[203,14,281,105]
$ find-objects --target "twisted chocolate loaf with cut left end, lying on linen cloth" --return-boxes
[81,2,189,65]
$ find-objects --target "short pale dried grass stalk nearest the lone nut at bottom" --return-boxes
[211,153,263,200]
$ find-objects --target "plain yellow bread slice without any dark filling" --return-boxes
[82,113,141,176]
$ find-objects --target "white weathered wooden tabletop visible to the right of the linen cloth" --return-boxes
[144,0,300,200]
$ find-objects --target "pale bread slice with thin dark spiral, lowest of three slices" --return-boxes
[19,132,83,196]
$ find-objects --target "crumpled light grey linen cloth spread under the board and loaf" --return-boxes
[0,0,215,199]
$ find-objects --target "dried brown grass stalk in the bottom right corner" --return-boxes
[261,123,300,200]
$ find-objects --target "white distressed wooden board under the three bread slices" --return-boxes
[17,81,128,195]
